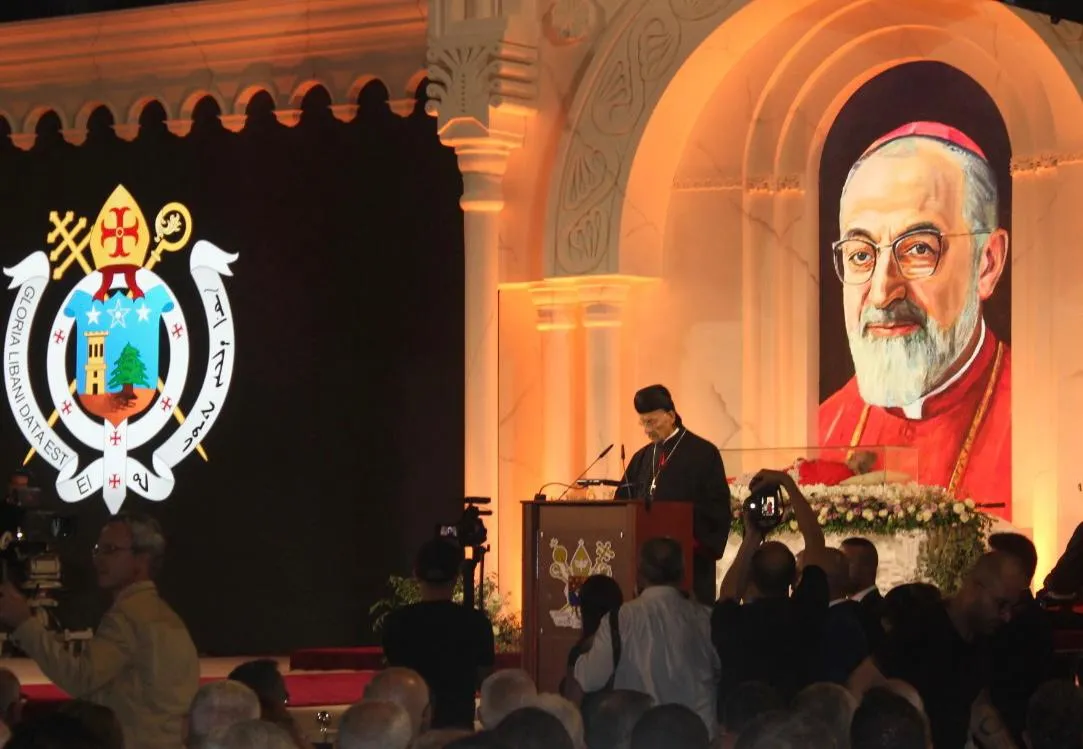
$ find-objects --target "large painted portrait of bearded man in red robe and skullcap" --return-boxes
[820,122,1012,503]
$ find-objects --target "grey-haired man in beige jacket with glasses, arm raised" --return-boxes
[0,514,199,749]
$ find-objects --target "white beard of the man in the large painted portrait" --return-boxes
[846,284,981,408]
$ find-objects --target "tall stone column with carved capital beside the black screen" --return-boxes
[426,27,537,577]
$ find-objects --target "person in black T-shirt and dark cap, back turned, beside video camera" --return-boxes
[383,537,496,730]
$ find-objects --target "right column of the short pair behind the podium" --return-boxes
[579,282,631,478]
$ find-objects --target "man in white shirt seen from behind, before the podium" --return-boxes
[575,538,720,737]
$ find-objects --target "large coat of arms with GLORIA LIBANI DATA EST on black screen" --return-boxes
[3,185,237,513]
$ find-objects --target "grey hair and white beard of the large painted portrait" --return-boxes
[839,135,1000,408]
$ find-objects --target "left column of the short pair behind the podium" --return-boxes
[531,286,578,481]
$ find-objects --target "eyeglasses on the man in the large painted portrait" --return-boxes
[831,228,991,285]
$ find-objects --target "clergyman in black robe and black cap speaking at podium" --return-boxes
[616,385,730,605]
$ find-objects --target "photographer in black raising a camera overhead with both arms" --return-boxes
[710,469,828,705]
